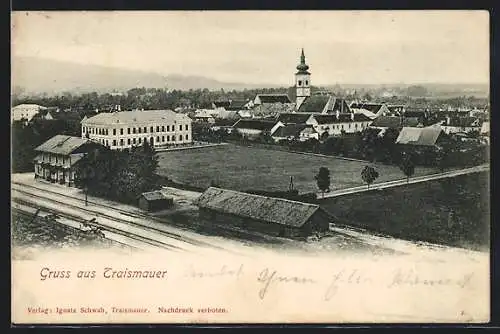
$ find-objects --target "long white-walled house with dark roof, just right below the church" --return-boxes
[313,113,372,138]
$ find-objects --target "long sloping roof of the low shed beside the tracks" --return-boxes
[195,187,326,227]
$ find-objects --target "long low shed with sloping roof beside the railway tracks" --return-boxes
[194,187,336,237]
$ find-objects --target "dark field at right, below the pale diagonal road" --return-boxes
[320,172,490,251]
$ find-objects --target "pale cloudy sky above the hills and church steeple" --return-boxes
[11,10,490,85]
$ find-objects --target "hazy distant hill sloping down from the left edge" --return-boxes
[12,57,278,95]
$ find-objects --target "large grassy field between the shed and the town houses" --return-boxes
[158,145,435,193]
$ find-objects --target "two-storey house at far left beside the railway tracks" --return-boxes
[33,135,103,186]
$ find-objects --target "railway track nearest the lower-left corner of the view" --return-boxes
[12,199,182,251]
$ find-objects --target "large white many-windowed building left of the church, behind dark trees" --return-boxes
[81,110,193,149]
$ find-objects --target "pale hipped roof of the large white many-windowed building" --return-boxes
[82,110,189,124]
